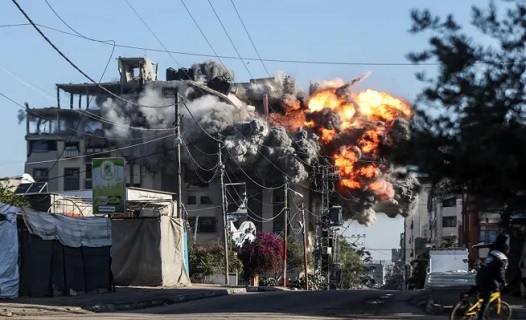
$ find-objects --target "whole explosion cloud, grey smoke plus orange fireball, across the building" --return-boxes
[92,61,419,225]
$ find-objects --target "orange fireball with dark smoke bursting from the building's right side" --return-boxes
[305,79,419,225]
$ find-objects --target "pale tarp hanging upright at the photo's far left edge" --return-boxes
[0,203,20,299]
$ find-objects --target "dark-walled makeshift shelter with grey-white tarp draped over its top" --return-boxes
[20,208,112,297]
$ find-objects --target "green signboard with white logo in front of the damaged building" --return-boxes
[92,158,126,215]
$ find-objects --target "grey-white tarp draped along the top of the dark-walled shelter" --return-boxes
[22,208,111,248]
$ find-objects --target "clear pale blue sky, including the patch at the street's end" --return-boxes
[0,0,483,259]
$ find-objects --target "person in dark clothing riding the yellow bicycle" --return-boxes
[476,234,509,320]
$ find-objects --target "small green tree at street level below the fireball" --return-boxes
[338,238,367,289]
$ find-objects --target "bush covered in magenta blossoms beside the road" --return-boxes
[238,232,283,280]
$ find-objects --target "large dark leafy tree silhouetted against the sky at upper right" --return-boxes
[398,0,526,208]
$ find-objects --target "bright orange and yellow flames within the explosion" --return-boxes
[304,88,412,200]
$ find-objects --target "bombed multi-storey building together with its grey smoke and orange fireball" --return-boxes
[19,58,419,246]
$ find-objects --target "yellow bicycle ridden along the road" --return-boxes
[449,291,511,320]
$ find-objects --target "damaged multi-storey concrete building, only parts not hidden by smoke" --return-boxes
[25,57,315,243]
